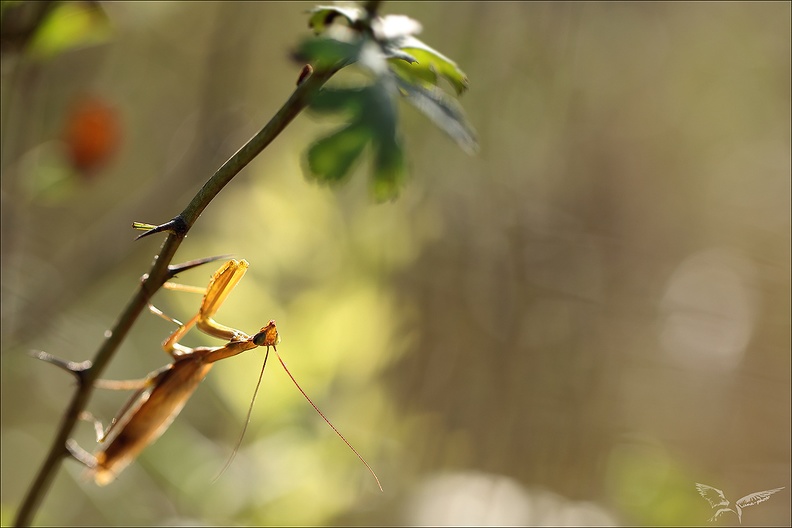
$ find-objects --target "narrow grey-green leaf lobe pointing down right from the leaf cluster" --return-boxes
[397,78,478,154]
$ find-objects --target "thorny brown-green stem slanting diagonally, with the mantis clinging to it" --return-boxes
[14,67,340,526]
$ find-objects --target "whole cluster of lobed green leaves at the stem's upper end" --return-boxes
[296,7,477,202]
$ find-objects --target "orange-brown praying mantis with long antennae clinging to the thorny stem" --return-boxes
[44,259,382,491]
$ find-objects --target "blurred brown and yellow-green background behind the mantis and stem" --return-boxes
[0,2,791,526]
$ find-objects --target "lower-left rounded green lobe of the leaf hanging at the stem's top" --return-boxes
[307,122,371,183]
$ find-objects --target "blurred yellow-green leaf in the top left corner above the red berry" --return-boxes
[28,2,112,59]
